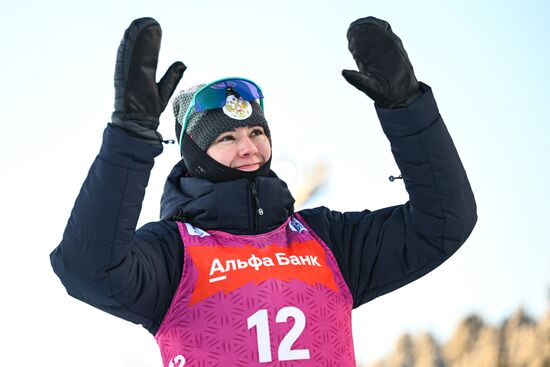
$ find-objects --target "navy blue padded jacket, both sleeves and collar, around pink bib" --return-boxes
[50,85,477,334]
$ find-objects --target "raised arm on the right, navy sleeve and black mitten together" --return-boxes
[302,17,477,307]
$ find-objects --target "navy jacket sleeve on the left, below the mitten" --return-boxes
[50,125,183,333]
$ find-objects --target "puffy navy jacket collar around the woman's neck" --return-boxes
[160,159,294,234]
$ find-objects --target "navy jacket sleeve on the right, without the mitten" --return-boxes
[300,84,477,307]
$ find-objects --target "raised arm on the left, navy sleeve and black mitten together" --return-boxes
[50,18,185,329]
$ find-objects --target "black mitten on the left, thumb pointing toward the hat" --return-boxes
[111,18,186,144]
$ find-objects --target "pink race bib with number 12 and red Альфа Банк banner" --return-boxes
[155,216,356,367]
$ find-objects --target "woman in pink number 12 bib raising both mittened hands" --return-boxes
[51,17,477,366]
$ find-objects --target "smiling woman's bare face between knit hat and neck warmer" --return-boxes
[206,126,271,171]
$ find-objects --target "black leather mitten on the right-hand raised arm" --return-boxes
[342,17,422,108]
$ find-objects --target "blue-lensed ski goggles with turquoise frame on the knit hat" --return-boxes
[180,78,264,142]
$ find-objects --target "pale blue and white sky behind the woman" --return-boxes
[0,0,550,367]
